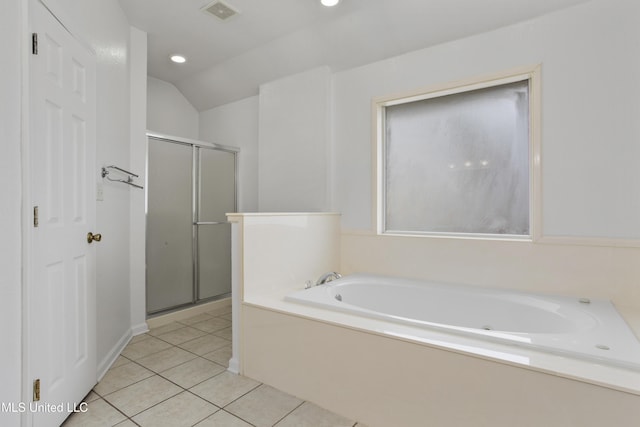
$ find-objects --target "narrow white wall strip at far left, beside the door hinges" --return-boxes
[0,1,22,426]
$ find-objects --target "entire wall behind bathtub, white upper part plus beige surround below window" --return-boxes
[334,0,640,310]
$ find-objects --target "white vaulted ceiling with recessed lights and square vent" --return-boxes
[119,0,587,111]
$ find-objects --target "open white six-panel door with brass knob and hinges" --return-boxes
[26,1,97,426]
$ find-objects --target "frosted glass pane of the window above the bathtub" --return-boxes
[384,80,529,235]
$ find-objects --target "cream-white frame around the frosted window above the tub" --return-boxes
[372,64,542,241]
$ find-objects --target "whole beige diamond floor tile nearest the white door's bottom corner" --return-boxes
[105,375,182,417]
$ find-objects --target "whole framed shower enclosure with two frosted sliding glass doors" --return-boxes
[146,133,239,315]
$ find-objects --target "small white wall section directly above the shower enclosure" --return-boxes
[147,77,198,139]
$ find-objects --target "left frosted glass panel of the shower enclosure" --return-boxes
[147,141,193,313]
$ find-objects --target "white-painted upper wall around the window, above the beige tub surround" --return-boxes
[334,0,640,239]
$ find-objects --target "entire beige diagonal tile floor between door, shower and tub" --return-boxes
[63,308,366,427]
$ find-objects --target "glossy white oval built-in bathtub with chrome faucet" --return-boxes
[285,274,640,371]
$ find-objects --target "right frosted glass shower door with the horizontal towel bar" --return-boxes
[195,147,236,300]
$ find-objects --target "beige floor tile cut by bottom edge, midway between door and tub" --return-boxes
[133,391,219,427]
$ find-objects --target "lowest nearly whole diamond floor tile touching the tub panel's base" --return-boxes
[224,384,302,427]
